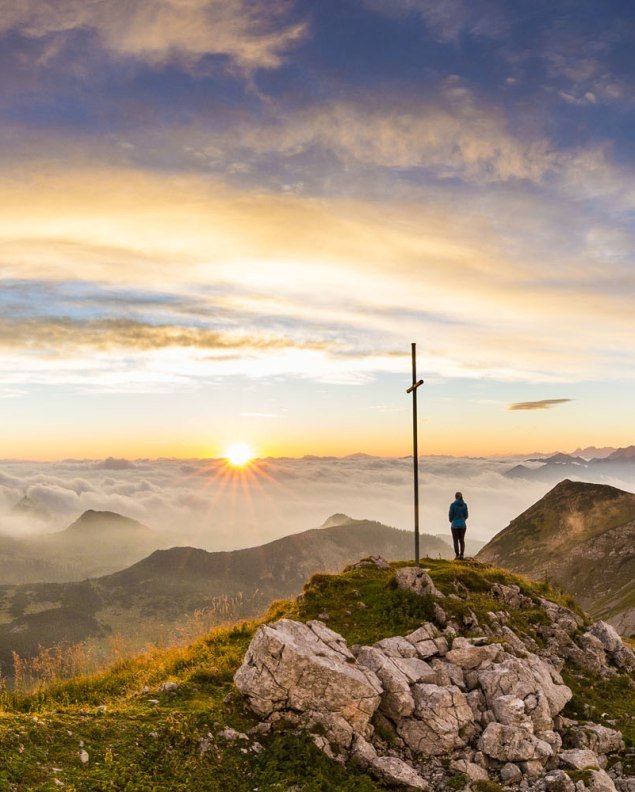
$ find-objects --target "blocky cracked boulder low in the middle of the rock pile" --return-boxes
[396,684,473,756]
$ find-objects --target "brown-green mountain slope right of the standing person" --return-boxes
[477,480,635,635]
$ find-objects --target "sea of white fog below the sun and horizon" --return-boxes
[0,455,635,550]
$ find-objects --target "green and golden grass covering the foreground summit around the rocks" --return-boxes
[0,559,635,792]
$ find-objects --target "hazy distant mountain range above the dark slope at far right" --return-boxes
[505,445,635,483]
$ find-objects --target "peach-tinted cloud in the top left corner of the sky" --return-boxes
[0,0,306,69]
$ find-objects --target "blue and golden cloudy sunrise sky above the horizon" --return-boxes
[0,0,635,460]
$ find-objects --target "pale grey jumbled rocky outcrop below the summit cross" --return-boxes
[235,568,630,792]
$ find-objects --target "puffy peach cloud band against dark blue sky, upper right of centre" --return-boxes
[234,86,558,183]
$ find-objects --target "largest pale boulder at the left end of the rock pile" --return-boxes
[234,619,382,745]
